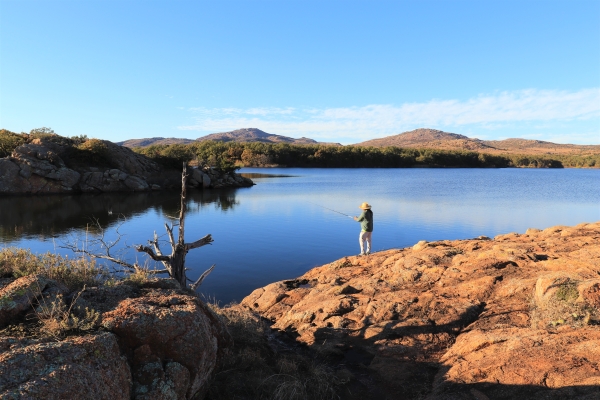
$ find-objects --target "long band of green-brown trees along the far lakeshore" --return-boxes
[134,141,600,170]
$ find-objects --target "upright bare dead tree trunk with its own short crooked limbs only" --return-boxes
[135,163,215,290]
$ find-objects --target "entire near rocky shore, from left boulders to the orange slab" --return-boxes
[0,222,600,400]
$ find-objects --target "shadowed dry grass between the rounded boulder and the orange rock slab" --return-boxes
[206,304,338,400]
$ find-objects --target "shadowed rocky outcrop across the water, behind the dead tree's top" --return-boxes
[0,137,253,195]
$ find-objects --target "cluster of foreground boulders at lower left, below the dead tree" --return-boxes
[0,276,232,400]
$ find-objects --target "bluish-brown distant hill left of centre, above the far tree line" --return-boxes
[117,128,341,147]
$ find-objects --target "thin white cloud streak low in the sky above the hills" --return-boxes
[179,88,600,143]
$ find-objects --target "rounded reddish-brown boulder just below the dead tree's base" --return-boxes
[103,290,230,399]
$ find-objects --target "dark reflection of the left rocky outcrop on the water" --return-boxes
[0,189,244,243]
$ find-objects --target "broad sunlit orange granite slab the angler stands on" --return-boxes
[242,223,600,400]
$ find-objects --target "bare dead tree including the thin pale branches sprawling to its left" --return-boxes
[61,163,215,290]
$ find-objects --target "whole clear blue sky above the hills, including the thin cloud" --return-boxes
[0,0,600,144]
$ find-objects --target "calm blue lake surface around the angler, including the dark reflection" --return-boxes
[0,169,600,303]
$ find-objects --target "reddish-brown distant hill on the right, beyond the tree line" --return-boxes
[355,128,600,155]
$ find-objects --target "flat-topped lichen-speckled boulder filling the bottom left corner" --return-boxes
[0,332,131,400]
